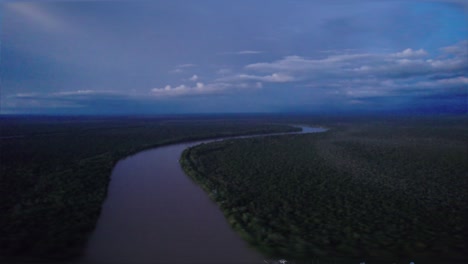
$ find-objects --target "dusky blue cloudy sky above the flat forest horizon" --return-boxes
[0,0,468,115]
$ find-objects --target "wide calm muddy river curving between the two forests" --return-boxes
[81,126,326,264]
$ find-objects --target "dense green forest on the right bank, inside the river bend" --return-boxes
[181,117,468,263]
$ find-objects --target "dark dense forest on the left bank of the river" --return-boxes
[0,116,298,262]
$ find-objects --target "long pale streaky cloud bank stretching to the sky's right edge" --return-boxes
[245,42,468,79]
